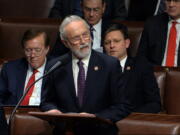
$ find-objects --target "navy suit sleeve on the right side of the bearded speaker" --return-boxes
[96,61,133,122]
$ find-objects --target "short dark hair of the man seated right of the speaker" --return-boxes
[104,23,129,39]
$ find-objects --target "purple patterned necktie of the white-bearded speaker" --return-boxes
[77,60,85,106]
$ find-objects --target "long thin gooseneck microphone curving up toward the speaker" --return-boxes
[8,54,69,125]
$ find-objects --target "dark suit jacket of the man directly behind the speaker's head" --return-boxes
[49,20,111,57]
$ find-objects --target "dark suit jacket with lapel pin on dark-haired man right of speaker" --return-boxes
[123,57,161,113]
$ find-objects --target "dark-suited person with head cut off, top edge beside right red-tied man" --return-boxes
[127,0,165,21]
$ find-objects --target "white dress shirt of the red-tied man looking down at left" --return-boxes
[24,60,46,106]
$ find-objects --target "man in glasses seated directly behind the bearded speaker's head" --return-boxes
[50,0,116,56]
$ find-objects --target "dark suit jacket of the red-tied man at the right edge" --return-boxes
[137,13,180,66]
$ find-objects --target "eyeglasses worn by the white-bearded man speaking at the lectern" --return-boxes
[69,32,90,44]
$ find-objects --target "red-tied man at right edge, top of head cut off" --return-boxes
[138,0,180,67]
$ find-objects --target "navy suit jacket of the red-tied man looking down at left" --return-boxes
[0,58,57,105]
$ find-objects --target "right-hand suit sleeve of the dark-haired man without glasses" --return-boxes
[135,57,161,113]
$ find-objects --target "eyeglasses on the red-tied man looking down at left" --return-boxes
[24,48,43,56]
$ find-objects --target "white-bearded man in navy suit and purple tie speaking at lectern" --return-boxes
[41,16,131,135]
